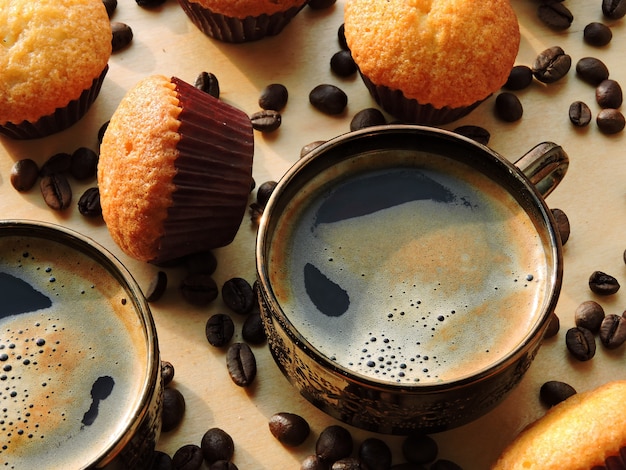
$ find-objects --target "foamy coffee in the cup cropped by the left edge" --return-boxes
[0,236,148,470]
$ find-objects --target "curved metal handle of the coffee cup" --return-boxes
[515,142,569,197]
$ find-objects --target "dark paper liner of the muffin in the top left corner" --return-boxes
[0,65,109,140]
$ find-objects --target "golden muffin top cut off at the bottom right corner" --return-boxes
[492,381,626,470]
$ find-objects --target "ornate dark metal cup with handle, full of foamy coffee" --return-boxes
[256,125,568,434]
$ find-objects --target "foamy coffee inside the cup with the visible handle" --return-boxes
[269,152,550,384]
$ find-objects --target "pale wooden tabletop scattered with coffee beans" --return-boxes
[0,0,626,470]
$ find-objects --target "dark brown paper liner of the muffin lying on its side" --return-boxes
[152,77,254,264]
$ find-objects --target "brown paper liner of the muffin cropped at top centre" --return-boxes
[178,0,306,43]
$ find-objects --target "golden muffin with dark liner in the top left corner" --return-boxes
[0,0,112,139]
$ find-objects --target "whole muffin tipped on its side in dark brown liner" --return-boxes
[98,75,254,264]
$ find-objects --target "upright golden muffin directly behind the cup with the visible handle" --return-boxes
[344,0,520,125]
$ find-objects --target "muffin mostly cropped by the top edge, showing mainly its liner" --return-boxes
[178,0,308,43]
